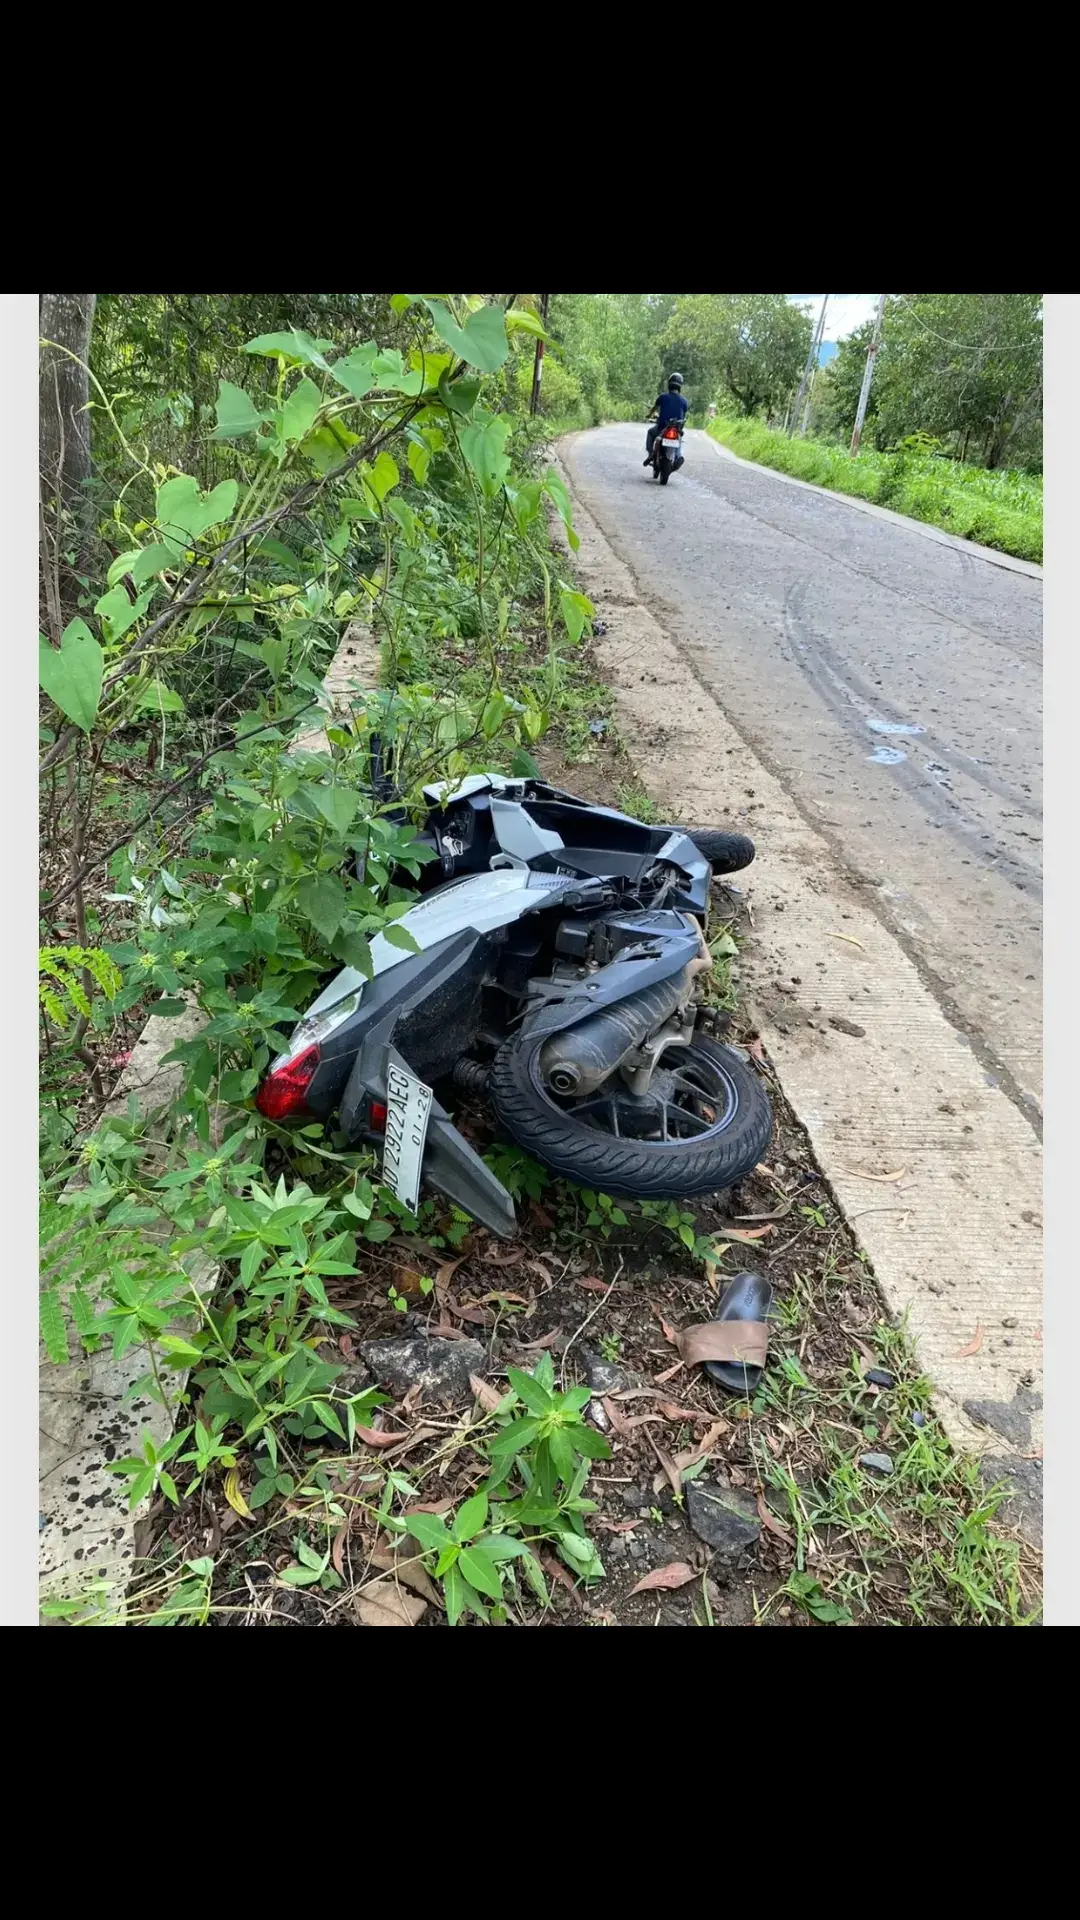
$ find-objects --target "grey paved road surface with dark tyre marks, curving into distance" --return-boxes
[563,426,1042,1117]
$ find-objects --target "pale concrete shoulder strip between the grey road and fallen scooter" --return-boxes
[549,441,1042,1532]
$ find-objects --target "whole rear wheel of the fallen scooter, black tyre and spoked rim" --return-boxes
[488,1033,773,1200]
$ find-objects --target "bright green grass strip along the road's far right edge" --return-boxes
[707,420,1042,563]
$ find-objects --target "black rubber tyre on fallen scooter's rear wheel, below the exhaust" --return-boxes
[488,1033,773,1200]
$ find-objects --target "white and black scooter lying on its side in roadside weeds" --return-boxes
[256,774,773,1236]
